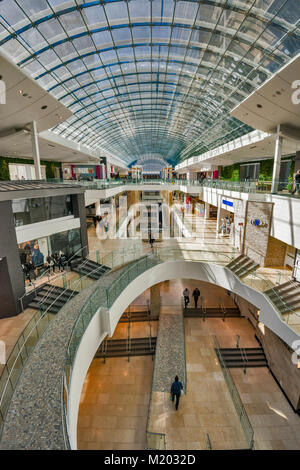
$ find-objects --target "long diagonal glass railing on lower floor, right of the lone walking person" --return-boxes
[214,336,254,449]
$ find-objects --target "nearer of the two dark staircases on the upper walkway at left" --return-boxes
[28,284,78,313]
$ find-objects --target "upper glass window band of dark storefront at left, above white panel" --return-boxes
[12,195,73,227]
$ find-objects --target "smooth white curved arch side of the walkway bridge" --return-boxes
[68,261,299,449]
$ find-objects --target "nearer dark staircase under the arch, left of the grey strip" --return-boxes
[95,337,156,358]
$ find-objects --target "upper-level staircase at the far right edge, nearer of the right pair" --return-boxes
[264,281,300,313]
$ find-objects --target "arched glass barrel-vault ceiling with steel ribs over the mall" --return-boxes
[0,0,300,164]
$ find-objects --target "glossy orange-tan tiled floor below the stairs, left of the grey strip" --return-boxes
[78,356,153,450]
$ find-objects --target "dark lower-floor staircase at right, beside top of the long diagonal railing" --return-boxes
[220,348,268,369]
